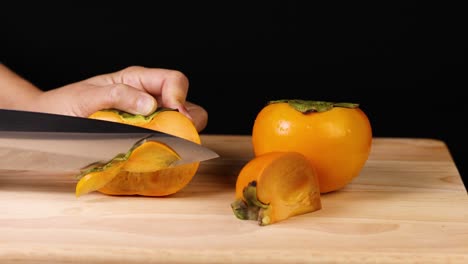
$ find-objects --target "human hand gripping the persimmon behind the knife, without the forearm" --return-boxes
[30,66,208,132]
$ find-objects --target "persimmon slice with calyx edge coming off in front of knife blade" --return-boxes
[75,141,181,197]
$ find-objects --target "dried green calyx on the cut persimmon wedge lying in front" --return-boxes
[231,181,270,226]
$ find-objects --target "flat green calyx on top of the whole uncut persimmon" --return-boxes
[268,99,359,114]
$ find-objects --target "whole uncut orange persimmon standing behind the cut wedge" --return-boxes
[252,100,372,193]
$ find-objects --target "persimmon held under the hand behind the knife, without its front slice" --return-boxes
[89,110,201,196]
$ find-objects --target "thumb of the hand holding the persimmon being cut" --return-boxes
[80,83,157,115]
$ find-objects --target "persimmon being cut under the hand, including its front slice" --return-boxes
[76,108,201,196]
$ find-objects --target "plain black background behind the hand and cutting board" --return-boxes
[0,1,468,186]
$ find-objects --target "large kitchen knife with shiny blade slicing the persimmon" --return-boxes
[0,109,219,172]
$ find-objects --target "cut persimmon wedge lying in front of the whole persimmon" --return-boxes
[231,152,322,226]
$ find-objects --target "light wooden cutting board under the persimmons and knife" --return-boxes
[0,135,468,263]
